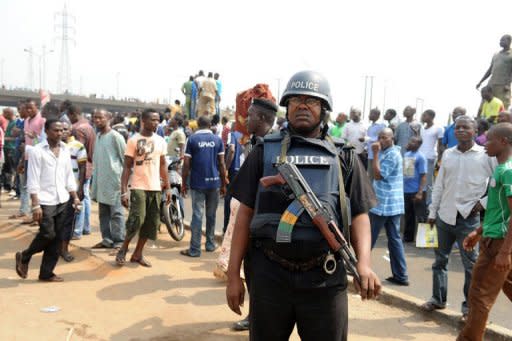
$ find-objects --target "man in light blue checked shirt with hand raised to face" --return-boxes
[370,128,409,286]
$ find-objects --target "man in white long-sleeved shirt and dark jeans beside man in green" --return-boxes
[422,116,496,319]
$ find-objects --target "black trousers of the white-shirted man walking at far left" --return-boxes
[21,201,71,279]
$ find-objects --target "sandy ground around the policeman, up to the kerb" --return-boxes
[0,202,456,341]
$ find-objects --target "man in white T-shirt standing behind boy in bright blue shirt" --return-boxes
[419,109,444,205]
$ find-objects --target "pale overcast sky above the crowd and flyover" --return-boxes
[0,0,512,123]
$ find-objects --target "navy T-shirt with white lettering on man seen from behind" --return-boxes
[185,129,224,189]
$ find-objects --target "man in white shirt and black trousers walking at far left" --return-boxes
[16,119,80,282]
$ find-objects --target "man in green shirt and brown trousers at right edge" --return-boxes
[457,123,512,341]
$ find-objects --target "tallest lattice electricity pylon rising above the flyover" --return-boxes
[54,4,76,93]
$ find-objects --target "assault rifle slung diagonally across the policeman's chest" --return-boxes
[260,162,361,285]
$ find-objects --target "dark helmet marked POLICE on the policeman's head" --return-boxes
[279,71,332,111]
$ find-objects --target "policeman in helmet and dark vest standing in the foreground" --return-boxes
[226,71,381,341]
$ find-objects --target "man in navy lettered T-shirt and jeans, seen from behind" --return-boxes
[180,116,227,257]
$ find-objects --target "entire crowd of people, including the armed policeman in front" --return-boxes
[0,36,512,340]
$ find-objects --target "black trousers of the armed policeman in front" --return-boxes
[246,248,348,341]
